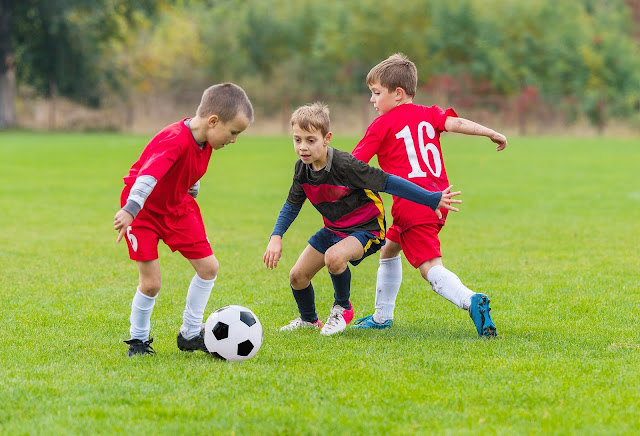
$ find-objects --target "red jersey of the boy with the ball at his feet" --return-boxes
[124,118,213,215]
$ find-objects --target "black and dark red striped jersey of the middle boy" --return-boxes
[287,147,389,238]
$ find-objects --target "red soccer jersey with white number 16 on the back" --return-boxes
[352,104,458,230]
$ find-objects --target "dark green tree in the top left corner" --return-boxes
[0,0,162,128]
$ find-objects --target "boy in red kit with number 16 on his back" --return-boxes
[352,53,507,337]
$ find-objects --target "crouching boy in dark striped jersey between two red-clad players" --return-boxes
[263,103,461,335]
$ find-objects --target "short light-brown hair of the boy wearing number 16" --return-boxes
[367,53,418,97]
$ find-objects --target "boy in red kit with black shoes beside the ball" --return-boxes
[113,83,253,357]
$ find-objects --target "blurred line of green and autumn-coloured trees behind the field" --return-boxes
[0,0,640,133]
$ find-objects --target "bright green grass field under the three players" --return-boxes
[0,132,640,435]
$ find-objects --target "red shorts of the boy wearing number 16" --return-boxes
[387,223,442,268]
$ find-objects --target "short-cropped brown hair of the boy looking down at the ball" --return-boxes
[196,82,253,123]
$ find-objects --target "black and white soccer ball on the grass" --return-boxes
[204,305,262,362]
